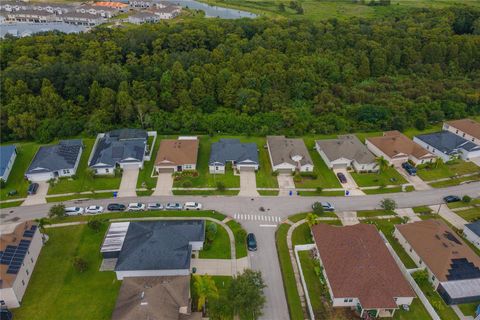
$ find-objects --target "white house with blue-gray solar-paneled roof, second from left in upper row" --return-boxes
[25,139,83,182]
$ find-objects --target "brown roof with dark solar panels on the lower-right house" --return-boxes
[396,219,480,281]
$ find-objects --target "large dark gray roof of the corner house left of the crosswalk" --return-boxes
[115,220,205,271]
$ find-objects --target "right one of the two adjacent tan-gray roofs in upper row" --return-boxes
[316,134,375,164]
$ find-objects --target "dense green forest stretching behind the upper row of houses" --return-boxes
[0,7,480,142]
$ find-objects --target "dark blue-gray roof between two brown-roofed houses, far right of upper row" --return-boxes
[417,131,480,155]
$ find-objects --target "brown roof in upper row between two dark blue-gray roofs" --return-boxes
[155,139,199,166]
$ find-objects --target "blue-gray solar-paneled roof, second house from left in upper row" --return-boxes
[26,139,83,174]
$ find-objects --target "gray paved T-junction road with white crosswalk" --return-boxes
[0,182,480,320]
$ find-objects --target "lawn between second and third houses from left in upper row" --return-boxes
[48,138,121,194]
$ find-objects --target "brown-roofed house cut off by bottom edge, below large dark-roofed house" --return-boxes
[112,275,202,320]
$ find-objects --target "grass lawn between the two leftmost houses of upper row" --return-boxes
[0,142,40,200]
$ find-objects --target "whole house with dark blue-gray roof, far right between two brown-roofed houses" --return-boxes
[413,130,480,162]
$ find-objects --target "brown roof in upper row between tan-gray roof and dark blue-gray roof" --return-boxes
[367,130,435,159]
